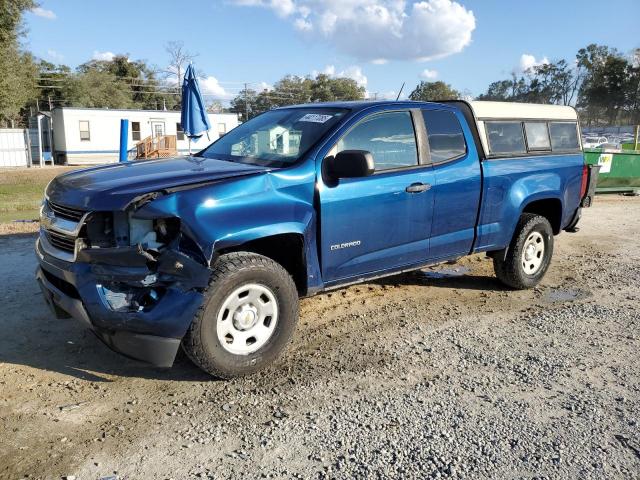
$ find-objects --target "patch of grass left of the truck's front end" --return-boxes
[0,167,78,230]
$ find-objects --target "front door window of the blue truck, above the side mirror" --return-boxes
[336,112,418,171]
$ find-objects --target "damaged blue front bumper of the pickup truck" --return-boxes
[36,239,203,367]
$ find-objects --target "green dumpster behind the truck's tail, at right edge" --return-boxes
[584,149,640,193]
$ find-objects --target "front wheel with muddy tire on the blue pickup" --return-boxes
[182,252,298,379]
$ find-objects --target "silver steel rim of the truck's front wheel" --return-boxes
[216,283,278,355]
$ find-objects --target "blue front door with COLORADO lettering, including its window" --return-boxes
[319,109,434,285]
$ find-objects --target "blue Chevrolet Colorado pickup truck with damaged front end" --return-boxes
[36,101,597,378]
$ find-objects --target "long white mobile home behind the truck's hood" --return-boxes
[52,107,239,164]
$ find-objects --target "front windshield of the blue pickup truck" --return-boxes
[198,107,348,167]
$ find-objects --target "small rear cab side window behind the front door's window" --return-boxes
[422,110,467,163]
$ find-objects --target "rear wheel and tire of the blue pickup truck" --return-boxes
[493,213,553,290]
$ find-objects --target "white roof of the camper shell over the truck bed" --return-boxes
[469,101,578,121]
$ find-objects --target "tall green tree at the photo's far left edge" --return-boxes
[0,0,37,126]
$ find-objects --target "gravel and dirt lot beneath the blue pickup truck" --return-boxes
[0,197,640,479]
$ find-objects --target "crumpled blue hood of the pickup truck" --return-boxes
[46,157,269,210]
